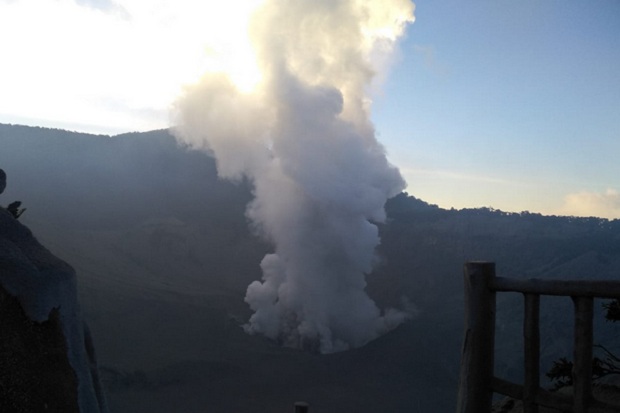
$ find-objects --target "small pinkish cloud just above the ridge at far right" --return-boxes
[558,189,620,219]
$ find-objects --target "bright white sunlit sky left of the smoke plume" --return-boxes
[0,0,261,130]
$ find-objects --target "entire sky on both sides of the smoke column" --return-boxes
[0,0,620,218]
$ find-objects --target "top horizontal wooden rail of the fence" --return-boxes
[491,277,620,298]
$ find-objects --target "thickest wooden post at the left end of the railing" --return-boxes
[457,262,495,413]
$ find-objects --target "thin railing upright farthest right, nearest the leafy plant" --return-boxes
[573,297,594,413]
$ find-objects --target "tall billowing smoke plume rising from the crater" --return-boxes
[176,0,414,353]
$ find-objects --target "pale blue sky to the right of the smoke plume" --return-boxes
[374,0,620,217]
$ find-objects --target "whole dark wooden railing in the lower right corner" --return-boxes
[457,262,620,413]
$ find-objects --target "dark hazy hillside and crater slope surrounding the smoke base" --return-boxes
[0,125,620,413]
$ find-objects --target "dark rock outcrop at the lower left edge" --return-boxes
[0,208,107,413]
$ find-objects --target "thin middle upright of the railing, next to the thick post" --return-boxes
[523,294,540,413]
